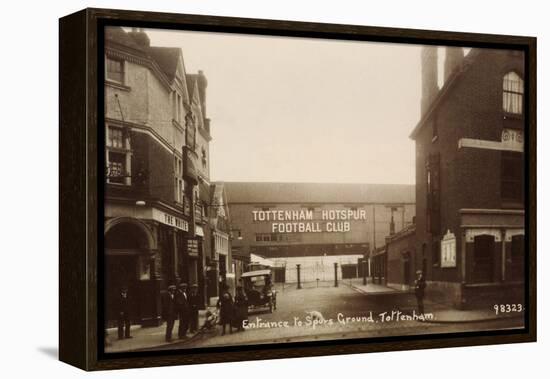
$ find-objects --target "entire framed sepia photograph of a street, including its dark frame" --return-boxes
[59,9,536,370]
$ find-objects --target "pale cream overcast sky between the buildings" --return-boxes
[147,29,426,184]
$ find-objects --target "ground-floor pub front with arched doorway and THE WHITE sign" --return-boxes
[104,204,192,327]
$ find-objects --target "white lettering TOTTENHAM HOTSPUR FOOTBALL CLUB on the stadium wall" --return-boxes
[252,209,367,233]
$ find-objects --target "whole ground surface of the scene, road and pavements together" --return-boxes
[105,279,523,352]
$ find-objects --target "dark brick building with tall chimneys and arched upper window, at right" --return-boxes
[411,47,525,307]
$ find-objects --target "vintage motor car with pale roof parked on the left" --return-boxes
[241,270,277,313]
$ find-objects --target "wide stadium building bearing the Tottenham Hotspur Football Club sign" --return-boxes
[225,182,415,282]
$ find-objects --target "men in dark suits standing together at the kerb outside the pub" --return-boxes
[163,283,201,342]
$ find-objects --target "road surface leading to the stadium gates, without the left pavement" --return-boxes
[148,282,523,350]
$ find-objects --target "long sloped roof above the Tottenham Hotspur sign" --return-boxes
[224,182,415,204]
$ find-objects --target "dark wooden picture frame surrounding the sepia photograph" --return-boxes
[59,9,537,370]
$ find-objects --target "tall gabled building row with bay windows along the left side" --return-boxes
[104,27,226,325]
